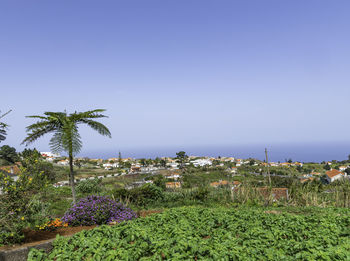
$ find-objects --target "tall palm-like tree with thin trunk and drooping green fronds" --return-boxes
[22,109,111,204]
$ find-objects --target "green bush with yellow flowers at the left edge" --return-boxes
[0,161,49,246]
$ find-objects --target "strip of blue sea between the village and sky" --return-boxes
[78,142,350,162]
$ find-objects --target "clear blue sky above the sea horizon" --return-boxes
[0,0,350,159]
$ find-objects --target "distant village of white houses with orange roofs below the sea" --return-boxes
[0,148,350,191]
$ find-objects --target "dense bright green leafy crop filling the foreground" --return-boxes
[28,207,350,261]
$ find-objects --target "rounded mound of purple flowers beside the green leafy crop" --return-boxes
[61,195,137,226]
